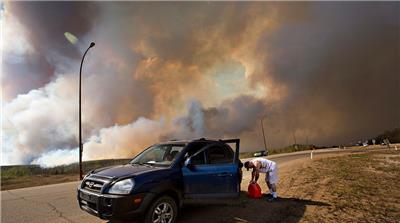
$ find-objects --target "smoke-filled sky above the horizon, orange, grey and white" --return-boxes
[1,1,400,167]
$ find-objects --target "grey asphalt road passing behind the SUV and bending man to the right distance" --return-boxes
[1,149,360,223]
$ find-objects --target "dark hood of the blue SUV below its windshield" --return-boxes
[92,164,166,178]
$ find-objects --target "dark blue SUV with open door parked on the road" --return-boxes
[77,138,243,223]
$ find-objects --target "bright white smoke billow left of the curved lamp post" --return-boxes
[2,76,78,164]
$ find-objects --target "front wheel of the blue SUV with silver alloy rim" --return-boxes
[144,196,178,223]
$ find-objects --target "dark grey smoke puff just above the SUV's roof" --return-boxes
[170,95,265,138]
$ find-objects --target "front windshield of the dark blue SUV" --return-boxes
[130,144,185,166]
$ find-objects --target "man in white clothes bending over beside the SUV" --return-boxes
[244,158,279,201]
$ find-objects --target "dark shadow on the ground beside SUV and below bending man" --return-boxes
[109,191,330,223]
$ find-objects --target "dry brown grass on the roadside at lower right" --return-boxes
[288,150,400,222]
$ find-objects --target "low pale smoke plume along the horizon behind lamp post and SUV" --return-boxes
[31,117,167,167]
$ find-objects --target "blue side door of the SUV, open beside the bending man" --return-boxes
[182,139,241,198]
